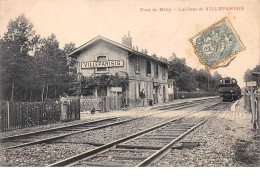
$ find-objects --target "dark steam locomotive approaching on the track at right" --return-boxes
[218,77,241,101]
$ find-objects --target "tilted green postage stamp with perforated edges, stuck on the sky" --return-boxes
[190,17,245,70]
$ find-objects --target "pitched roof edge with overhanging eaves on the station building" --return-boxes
[68,35,168,64]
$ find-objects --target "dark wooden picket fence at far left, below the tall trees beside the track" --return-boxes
[0,100,80,131]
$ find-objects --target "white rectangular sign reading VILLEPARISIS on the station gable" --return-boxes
[81,60,124,69]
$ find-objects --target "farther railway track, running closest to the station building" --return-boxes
[0,99,219,150]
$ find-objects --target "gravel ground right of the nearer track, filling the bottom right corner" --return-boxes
[153,101,260,167]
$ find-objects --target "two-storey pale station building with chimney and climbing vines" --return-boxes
[68,32,169,106]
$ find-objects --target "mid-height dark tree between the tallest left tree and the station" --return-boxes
[35,34,71,101]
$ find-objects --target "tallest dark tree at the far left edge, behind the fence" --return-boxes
[0,15,39,100]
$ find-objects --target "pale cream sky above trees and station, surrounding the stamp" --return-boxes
[0,0,260,87]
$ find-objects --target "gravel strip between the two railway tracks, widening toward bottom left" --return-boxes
[0,107,185,166]
